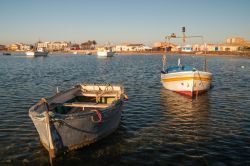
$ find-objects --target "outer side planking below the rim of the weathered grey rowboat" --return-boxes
[29,102,122,156]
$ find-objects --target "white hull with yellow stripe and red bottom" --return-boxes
[161,71,212,97]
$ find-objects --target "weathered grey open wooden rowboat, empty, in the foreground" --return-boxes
[29,84,127,158]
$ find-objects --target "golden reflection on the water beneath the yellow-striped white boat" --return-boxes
[160,89,211,143]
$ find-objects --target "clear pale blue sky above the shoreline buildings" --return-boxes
[0,0,250,45]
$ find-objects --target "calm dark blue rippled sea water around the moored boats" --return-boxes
[0,54,250,165]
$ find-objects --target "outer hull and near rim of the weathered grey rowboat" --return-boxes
[29,83,124,157]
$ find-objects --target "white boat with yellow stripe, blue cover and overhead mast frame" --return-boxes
[161,27,212,97]
